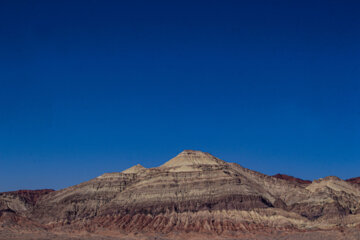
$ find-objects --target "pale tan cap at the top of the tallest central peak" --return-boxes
[162,150,225,167]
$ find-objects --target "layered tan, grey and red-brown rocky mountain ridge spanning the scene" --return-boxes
[0,150,360,239]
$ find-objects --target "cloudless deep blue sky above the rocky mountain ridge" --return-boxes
[0,0,360,191]
